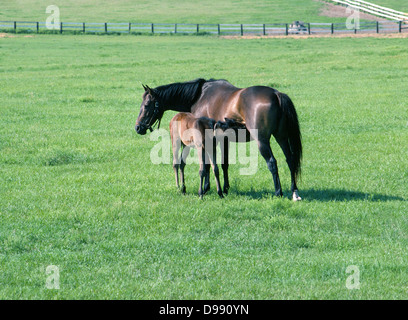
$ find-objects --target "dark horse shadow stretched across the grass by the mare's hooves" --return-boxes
[231,189,406,202]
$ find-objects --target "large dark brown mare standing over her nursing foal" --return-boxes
[135,79,302,201]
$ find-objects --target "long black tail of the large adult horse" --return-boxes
[276,92,302,180]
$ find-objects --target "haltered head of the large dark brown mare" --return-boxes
[135,85,163,135]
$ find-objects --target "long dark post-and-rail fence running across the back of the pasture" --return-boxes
[0,20,408,36]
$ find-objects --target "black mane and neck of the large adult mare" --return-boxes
[153,78,211,108]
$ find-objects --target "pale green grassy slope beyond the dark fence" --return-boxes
[0,0,356,23]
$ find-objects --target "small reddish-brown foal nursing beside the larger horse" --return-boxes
[170,112,245,199]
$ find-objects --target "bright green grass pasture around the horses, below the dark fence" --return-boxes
[0,35,408,299]
